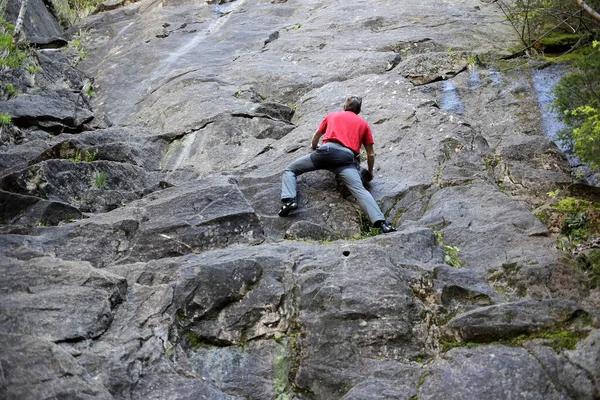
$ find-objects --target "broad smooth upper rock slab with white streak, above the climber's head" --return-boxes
[82,1,512,131]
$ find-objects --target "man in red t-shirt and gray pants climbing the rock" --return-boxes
[279,96,396,233]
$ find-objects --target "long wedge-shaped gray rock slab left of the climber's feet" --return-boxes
[17,177,264,267]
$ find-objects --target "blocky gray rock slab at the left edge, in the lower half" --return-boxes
[0,258,126,341]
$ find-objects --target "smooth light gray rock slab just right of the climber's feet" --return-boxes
[419,182,559,271]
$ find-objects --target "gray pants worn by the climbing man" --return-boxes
[281,143,385,223]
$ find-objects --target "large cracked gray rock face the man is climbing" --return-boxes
[0,0,600,400]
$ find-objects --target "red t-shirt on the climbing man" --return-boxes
[318,111,375,154]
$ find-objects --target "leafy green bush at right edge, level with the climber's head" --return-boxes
[553,42,600,169]
